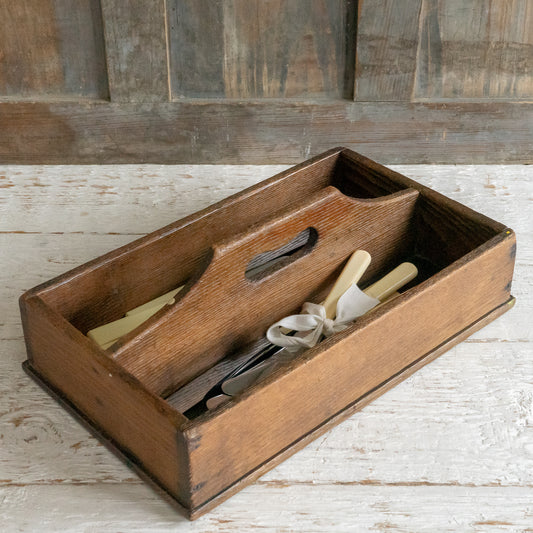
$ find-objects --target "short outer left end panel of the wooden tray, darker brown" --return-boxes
[21,296,189,507]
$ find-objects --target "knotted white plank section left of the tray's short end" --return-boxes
[0,340,140,484]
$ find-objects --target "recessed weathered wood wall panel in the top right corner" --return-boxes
[414,0,533,100]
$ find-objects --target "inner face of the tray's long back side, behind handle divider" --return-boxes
[34,149,339,333]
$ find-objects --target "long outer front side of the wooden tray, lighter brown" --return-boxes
[187,231,515,507]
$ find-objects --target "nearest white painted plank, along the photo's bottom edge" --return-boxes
[0,484,533,533]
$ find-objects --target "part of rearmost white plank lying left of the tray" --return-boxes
[0,165,287,235]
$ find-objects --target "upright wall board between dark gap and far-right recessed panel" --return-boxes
[354,0,422,101]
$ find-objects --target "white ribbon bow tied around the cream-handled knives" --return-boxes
[267,284,380,352]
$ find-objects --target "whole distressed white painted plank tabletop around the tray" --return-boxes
[0,165,533,533]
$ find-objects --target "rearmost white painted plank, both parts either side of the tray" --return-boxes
[0,165,533,234]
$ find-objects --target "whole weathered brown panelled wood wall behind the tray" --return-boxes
[0,0,533,164]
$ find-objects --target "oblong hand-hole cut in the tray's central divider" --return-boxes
[244,227,318,281]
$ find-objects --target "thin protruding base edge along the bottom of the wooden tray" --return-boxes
[22,296,515,520]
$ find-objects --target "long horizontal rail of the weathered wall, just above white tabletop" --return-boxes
[0,101,533,164]
